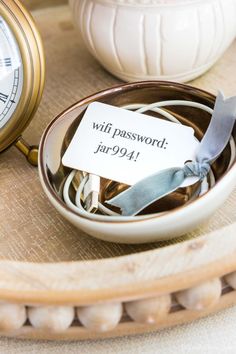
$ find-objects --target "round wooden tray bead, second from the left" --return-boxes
[28,306,75,332]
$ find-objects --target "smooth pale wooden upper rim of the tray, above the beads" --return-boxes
[0,224,236,306]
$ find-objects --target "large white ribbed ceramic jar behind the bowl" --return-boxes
[69,0,236,82]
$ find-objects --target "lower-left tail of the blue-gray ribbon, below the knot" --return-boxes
[106,168,185,216]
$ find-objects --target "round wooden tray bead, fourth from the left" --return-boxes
[125,295,171,324]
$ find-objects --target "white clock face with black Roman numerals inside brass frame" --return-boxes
[0,16,23,129]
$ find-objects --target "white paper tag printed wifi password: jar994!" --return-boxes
[62,102,199,185]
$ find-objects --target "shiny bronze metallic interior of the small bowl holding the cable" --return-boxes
[41,82,235,218]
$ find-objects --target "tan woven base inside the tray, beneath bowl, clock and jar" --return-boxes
[0,6,236,262]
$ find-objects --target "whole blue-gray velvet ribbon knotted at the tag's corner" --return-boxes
[107,92,236,216]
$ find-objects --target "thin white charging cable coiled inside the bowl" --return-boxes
[63,100,236,221]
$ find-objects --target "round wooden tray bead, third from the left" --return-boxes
[77,303,122,332]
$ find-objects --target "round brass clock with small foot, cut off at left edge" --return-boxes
[0,0,45,164]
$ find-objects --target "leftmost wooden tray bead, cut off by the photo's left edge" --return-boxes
[0,303,26,331]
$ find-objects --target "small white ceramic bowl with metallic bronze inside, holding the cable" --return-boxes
[39,81,236,243]
